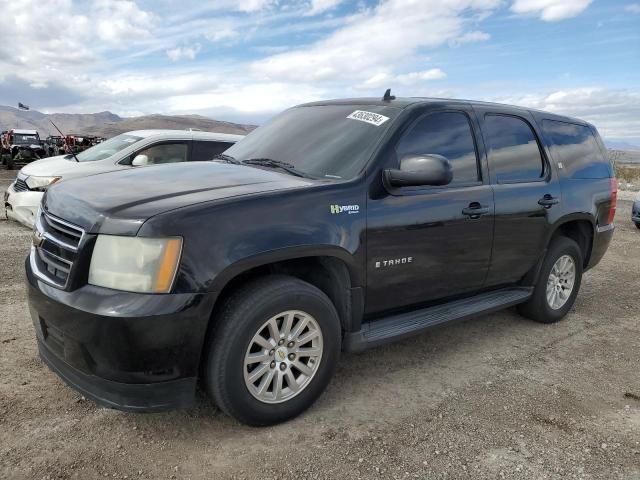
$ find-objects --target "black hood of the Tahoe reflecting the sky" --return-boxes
[44,162,313,235]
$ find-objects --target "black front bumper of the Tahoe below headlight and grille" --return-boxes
[25,260,215,411]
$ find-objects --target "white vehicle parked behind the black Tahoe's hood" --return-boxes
[4,130,244,227]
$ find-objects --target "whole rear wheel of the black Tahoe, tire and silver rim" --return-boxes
[518,237,584,323]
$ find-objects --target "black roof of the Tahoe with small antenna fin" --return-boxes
[299,97,587,124]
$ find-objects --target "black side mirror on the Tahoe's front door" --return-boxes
[384,154,453,187]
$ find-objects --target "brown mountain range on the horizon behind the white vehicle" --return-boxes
[0,105,255,138]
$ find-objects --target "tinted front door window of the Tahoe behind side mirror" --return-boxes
[395,112,480,184]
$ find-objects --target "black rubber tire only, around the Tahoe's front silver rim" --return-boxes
[209,287,341,425]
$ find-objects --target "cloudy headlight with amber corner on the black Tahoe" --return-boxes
[89,235,182,293]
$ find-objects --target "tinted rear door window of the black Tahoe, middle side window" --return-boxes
[483,115,544,183]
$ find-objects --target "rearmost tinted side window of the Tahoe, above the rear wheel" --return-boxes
[542,120,611,179]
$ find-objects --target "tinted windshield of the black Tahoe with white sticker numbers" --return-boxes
[225,105,400,179]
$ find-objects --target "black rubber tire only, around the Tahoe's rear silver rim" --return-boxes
[535,238,583,323]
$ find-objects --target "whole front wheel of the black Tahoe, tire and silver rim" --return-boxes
[203,275,342,426]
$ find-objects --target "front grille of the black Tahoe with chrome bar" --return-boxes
[31,210,84,288]
